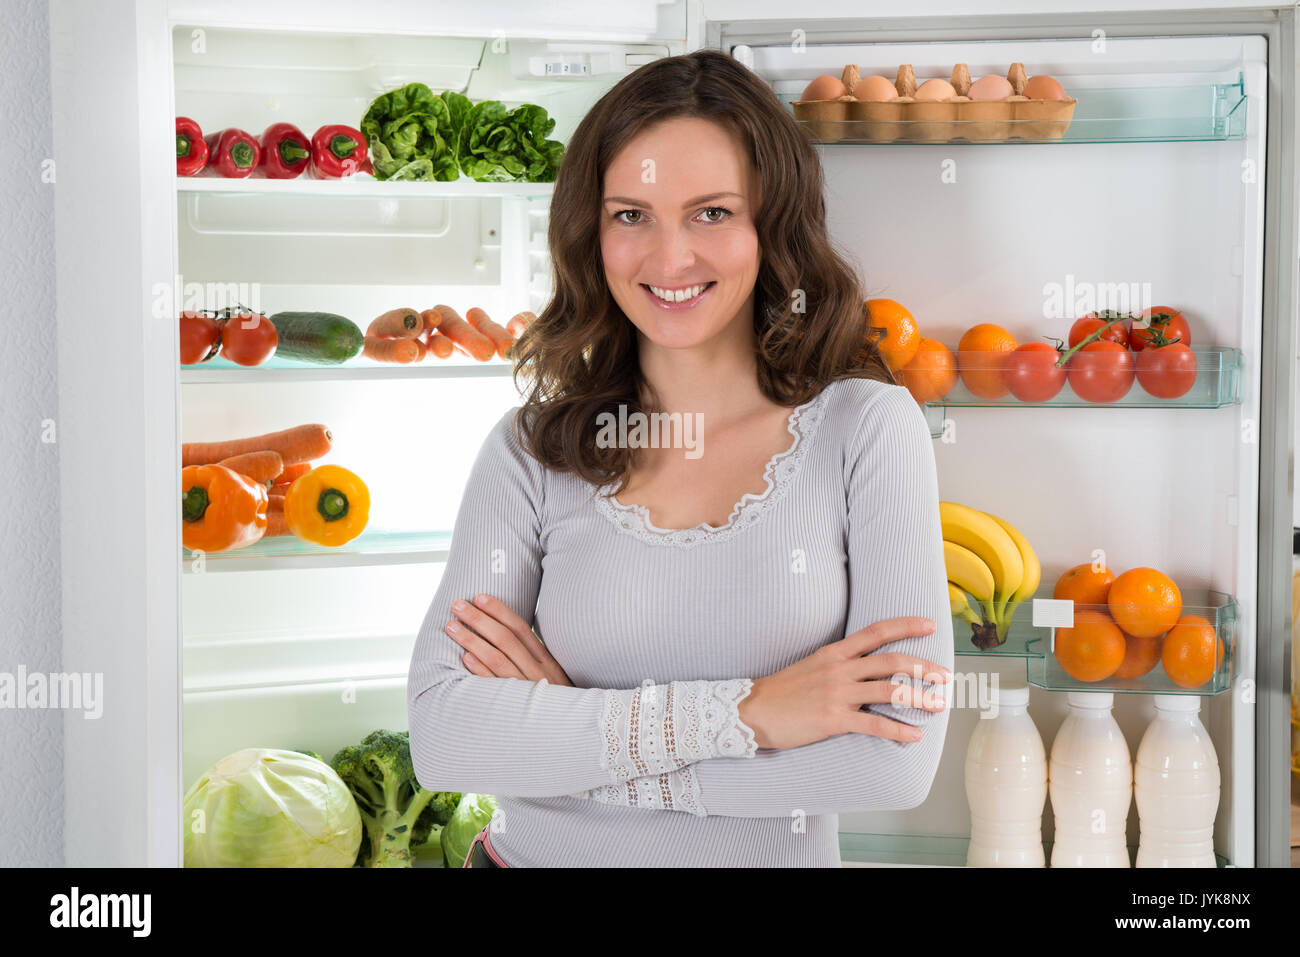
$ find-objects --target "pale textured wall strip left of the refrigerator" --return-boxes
[0,0,64,867]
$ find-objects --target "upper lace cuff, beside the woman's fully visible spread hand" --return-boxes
[601,677,758,784]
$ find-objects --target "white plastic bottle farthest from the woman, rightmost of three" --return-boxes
[1134,694,1219,867]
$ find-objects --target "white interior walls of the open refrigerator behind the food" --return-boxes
[173,26,1266,865]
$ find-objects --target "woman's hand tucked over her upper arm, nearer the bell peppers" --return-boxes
[446,594,573,687]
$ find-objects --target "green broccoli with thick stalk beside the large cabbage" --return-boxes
[330,731,460,867]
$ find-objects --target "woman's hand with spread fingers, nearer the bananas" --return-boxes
[738,618,953,748]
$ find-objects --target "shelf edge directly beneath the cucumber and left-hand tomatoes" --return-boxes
[181,355,515,385]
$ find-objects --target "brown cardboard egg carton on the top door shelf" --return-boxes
[790,62,1078,143]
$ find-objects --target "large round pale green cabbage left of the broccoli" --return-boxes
[185,748,361,867]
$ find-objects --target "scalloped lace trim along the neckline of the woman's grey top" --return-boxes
[595,382,835,547]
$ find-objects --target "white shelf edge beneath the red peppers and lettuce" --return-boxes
[176,173,555,199]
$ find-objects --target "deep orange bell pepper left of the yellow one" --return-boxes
[181,465,268,551]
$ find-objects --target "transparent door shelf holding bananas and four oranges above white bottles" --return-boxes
[953,589,1240,696]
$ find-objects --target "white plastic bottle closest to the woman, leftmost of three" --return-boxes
[966,685,1048,867]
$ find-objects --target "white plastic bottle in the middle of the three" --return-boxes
[1048,692,1134,867]
